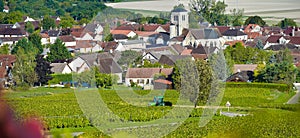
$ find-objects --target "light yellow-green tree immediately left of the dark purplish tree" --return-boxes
[13,47,38,86]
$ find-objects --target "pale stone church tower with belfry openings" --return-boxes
[170,7,189,38]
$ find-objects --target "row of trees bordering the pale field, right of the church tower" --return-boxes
[189,0,297,28]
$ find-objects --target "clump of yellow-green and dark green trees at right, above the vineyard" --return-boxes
[224,43,298,84]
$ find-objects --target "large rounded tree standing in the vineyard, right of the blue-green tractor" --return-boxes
[172,58,214,107]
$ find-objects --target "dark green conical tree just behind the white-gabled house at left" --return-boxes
[47,39,72,62]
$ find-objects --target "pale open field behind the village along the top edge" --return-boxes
[107,0,300,25]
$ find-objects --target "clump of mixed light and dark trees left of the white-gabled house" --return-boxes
[8,32,71,86]
